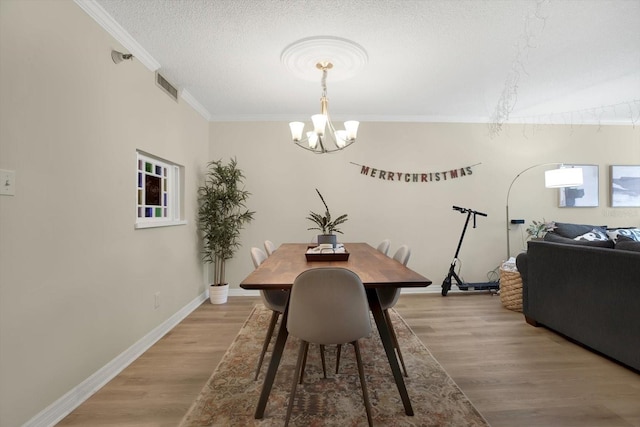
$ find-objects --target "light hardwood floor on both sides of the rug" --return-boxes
[58,292,640,427]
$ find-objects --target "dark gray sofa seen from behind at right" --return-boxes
[516,241,640,371]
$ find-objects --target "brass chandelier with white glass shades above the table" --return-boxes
[289,62,360,154]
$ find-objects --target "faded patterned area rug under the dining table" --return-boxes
[181,305,489,427]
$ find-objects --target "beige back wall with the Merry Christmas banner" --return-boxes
[210,123,640,292]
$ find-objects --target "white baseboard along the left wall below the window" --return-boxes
[23,292,207,427]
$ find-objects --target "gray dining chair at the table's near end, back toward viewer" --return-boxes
[284,267,373,426]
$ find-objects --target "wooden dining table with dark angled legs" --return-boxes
[240,243,431,419]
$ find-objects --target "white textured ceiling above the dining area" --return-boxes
[91,0,640,124]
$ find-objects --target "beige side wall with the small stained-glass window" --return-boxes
[0,0,209,427]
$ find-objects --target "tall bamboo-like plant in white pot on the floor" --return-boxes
[198,158,255,304]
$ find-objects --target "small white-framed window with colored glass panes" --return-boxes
[135,151,186,228]
